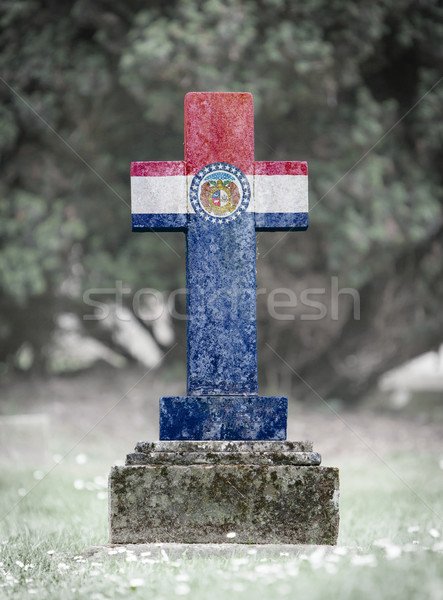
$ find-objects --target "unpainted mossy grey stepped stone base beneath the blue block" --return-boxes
[109,441,339,544]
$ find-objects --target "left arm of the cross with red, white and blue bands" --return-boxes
[131,161,188,231]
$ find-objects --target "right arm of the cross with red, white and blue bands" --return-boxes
[254,161,308,231]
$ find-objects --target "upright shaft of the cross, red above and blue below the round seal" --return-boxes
[185,93,258,396]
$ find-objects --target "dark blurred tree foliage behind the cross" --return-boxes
[0,0,443,401]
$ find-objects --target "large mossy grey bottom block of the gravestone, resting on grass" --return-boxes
[110,465,339,544]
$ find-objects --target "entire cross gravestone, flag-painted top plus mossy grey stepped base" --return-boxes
[109,93,339,544]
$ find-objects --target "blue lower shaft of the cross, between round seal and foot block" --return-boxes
[186,213,258,395]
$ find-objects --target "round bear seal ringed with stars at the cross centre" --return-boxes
[190,163,251,224]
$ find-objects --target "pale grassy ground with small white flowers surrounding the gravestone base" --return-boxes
[0,367,443,600]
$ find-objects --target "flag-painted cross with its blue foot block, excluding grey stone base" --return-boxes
[131,93,308,440]
